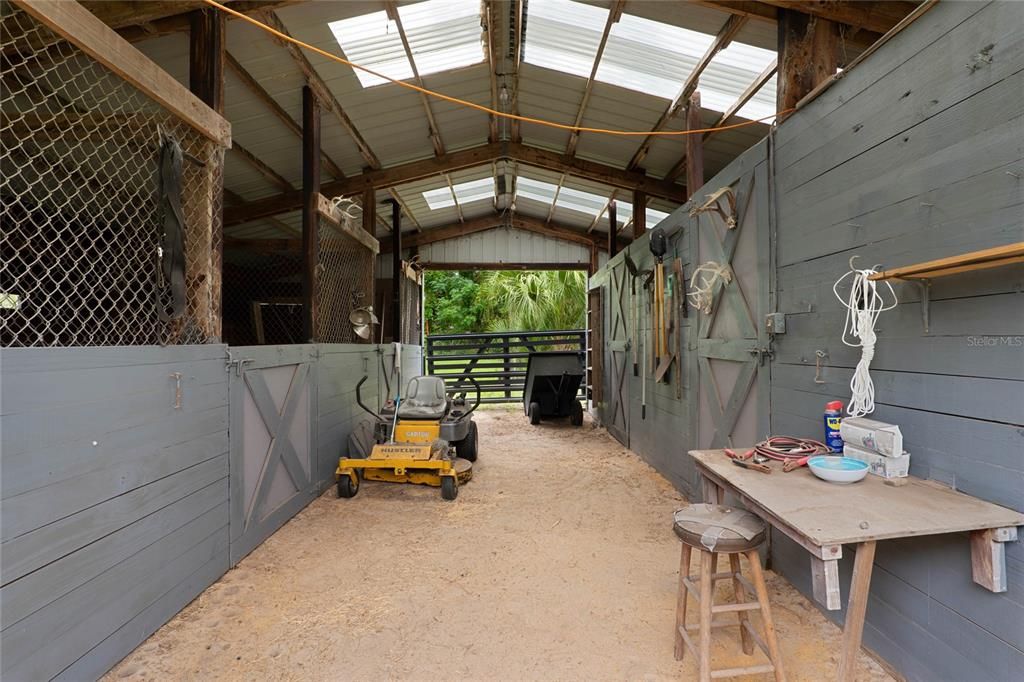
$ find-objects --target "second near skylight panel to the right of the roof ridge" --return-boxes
[598,14,715,99]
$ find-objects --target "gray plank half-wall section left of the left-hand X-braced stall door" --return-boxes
[0,344,228,680]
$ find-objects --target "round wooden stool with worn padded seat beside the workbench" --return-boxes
[673,504,785,682]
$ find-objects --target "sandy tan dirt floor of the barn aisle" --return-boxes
[108,410,892,680]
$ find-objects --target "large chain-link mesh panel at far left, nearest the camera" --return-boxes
[0,10,223,347]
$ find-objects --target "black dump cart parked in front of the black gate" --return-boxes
[522,350,586,426]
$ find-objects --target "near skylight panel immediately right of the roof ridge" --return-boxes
[523,0,608,78]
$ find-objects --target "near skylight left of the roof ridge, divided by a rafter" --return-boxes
[328,0,484,87]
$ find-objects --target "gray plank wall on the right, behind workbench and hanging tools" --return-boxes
[593,2,1024,680]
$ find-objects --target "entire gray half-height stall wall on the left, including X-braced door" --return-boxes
[0,344,420,680]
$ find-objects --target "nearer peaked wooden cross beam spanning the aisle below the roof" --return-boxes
[224,142,686,225]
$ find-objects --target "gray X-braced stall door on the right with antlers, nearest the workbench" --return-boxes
[691,157,771,456]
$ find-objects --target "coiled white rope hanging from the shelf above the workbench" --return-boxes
[833,256,898,417]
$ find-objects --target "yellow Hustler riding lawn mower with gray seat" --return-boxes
[335,376,480,500]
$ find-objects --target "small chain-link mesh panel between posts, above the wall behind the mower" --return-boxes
[316,204,377,343]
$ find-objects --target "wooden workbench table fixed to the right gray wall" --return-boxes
[690,447,1024,682]
